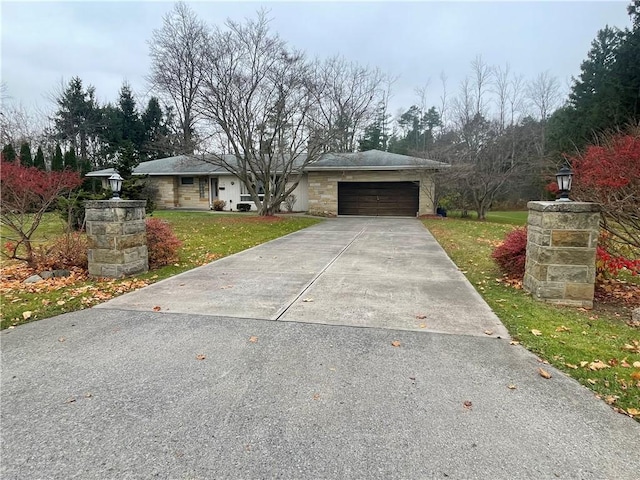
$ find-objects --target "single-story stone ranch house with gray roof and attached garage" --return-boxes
[87,150,448,216]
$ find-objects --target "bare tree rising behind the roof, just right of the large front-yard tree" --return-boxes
[315,57,386,152]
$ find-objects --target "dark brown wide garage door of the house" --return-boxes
[338,182,420,217]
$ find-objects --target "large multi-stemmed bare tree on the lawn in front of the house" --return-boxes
[198,11,334,215]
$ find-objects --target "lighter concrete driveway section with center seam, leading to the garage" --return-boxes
[92,218,507,338]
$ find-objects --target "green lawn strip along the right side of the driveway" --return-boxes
[423,216,640,419]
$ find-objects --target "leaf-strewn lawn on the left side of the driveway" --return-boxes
[0,211,321,329]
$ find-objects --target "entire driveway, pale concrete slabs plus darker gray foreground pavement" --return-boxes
[0,219,640,479]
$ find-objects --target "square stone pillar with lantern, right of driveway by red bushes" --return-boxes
[524,202,600,308]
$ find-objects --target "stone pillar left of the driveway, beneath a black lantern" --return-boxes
[85,200,149,278]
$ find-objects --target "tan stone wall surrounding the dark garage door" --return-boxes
[308,170,435,215]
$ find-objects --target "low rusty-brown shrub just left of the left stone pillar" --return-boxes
[33,232,89,270]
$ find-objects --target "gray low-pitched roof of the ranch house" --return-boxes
[87,150,449,177]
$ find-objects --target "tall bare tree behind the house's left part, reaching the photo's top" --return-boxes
[147,2,207,153]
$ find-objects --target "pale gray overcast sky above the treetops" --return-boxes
[0,0,631,121]
